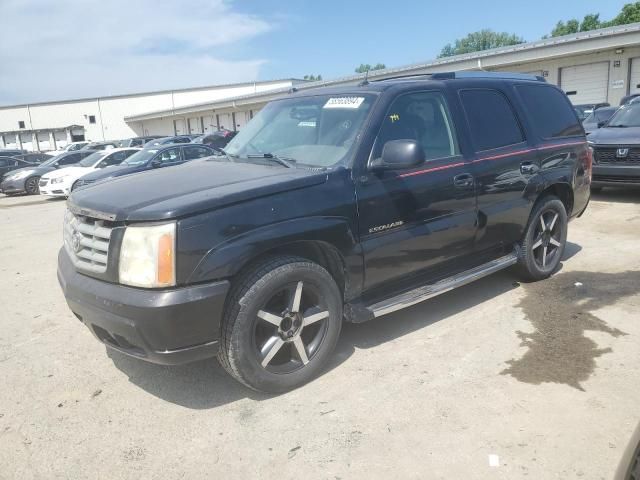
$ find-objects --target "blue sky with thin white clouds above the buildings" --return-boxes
[0,0,625,105]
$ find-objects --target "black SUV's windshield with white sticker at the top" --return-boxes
[225,94,375,167]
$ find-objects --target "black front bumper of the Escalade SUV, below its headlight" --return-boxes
[58,248,229,365]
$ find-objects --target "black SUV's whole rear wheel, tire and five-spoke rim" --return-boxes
[518,195,567,281]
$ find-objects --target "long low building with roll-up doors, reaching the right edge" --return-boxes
[125,23,640,133]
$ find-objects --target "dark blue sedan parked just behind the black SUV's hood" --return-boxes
[71,143,216,192]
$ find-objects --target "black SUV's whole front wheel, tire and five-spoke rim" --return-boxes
[218,256,342,393]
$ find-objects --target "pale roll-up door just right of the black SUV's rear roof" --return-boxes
[560,62,609,105]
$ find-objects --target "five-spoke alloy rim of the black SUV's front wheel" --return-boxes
[253,281,329,374]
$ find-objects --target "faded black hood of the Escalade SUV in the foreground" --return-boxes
[69,160,327,221]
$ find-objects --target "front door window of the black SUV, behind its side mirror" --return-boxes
[372,92,458,160]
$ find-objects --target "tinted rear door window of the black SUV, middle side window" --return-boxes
[460,89,524,151]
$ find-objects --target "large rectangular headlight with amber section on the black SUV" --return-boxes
[119,223,176,288]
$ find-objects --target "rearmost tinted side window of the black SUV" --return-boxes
[517,85,583,138]
